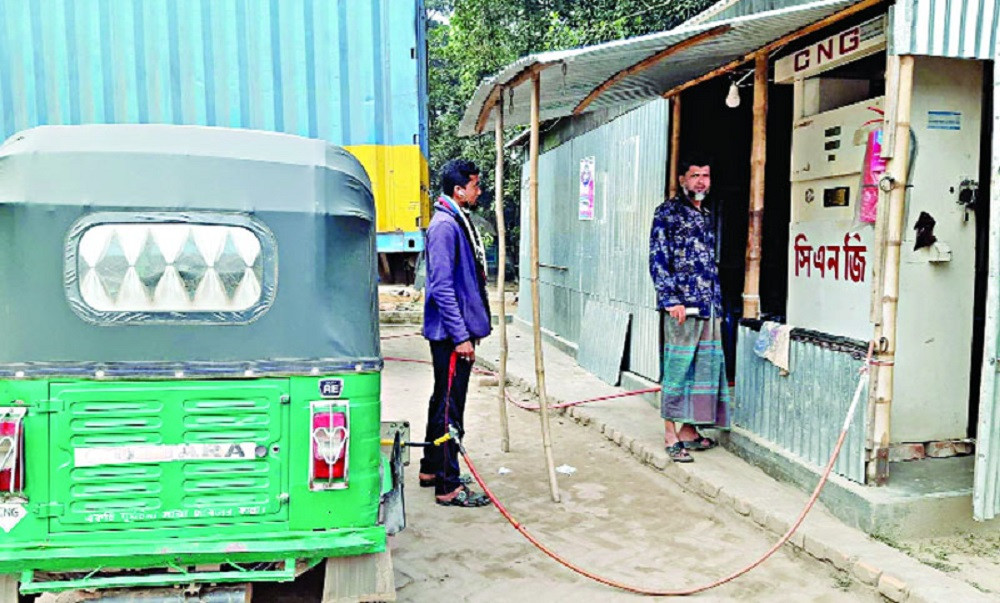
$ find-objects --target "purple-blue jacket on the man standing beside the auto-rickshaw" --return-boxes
[424,203,492,344]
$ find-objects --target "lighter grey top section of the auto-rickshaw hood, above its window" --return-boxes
[0,125,375,221]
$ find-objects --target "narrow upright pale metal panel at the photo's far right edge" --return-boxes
[972,56,1000,521]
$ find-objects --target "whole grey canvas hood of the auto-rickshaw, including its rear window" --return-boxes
[0,125,380,378]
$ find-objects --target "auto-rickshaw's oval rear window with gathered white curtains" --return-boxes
[66,213,277,324]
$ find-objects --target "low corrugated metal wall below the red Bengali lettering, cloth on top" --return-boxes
[733,326,868,483]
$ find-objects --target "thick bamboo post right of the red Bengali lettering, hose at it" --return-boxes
[867,55,913,486]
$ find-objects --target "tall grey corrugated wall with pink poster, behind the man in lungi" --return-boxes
[518,100,669,380]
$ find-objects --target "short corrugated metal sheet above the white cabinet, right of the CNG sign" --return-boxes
[892,0,1000,60]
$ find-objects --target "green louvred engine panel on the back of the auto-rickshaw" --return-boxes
[50,379,288,532]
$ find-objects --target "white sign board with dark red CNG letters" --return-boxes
[774,15,885,83]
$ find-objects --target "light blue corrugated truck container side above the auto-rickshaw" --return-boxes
[0,0,427,155]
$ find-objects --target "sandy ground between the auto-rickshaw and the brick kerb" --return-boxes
[382,327,880,602]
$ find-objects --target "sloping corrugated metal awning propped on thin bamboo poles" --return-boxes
[459,0,856,136]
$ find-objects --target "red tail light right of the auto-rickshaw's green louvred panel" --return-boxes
[309,401,351,490]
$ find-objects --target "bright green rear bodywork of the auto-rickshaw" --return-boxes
[0,372,386,593]
